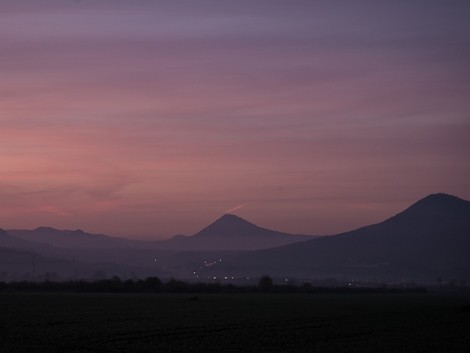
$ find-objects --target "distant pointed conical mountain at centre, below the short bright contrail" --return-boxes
[160,214,311,251]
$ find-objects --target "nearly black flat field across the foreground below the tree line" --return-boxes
[0,293,470,353]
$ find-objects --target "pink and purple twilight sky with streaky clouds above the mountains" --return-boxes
[0,0,470,239]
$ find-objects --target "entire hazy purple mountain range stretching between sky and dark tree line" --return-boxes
[0,194,470,281]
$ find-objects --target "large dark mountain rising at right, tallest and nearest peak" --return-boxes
[216,194,470,280]
